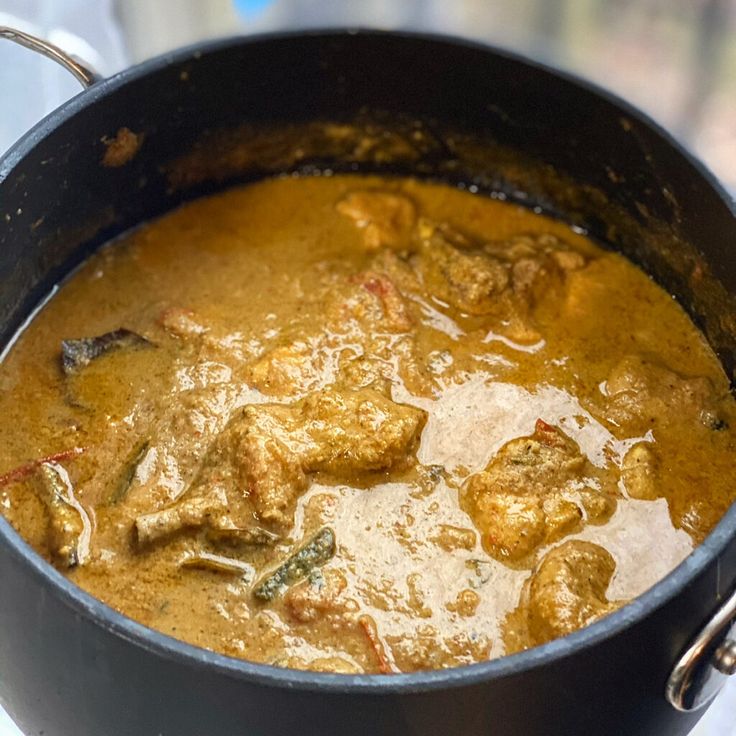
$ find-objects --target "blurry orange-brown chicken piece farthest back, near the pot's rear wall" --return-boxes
[335,189,416,250]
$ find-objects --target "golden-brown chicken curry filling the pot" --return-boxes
[0,175,736,673]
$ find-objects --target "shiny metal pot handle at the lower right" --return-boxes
[666,590,736,711]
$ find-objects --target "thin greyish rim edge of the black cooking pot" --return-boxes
[0,28,736,695]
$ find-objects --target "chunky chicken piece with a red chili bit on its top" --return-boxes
[462,419,616,562]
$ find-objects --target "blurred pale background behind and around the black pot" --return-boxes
[0,0,736,736]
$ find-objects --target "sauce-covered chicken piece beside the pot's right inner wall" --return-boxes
[606,355,726,434]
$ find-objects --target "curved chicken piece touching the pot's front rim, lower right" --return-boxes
[522,540,623,644]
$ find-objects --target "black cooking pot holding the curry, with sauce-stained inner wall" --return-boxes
[0,32,736,736]
